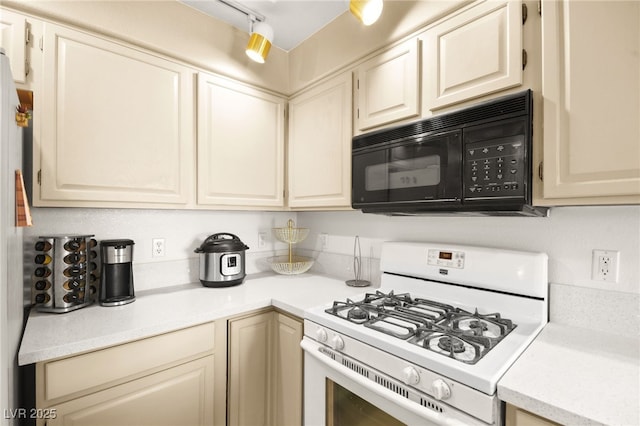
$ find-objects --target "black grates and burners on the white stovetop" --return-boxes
[325,291,516,364]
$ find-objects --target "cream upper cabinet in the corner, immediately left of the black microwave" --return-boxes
[288,73,352,208]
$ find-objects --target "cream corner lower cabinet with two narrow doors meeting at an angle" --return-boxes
[227,310,303,426]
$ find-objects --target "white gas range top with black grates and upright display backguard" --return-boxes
[305,242,548,395]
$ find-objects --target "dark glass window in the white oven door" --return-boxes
[326,379,404,426]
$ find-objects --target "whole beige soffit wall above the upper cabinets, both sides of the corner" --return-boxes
[3,0,470,94]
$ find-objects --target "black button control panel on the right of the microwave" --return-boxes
[462,137,526,198]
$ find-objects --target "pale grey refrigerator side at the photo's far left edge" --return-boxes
[0,49,23,426]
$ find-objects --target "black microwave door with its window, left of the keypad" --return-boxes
[351,130,462,211]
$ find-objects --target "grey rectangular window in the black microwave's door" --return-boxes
[365,155,441,191]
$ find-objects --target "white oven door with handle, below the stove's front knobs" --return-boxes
[301,337,486,426]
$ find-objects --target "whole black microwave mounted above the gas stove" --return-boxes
[351,90,548,216]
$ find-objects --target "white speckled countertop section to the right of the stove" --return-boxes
[498,323,640,426]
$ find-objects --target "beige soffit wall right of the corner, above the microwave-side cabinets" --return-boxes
[289,0,470,93]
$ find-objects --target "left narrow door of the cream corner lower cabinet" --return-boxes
[228,311,273,426]
